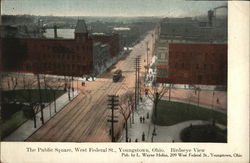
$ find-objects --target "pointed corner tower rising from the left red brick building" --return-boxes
[75,20,88,41]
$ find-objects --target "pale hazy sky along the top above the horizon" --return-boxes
[1,0,227,17]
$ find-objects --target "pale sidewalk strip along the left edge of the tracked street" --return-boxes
[3,91,79,141]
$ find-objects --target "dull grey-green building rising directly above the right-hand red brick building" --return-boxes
[160,17,227,42]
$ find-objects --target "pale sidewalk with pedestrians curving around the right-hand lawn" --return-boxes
[120,97,226,142]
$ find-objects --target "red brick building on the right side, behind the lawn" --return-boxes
[156,43,227,85]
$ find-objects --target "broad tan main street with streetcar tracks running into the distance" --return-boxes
[27,30,155,142]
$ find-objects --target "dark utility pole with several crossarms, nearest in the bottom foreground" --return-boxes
[108,95,119,142]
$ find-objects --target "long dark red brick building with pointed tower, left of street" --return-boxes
[0,20,119,76]
